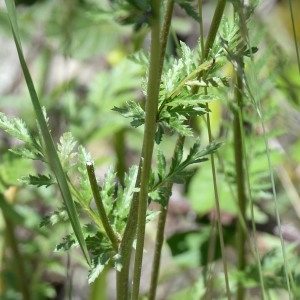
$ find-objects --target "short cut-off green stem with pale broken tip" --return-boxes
[86,162,119,251]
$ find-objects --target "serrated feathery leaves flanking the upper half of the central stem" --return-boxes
[114,32,241,143]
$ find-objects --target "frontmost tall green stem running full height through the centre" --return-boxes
[131,0,161,300]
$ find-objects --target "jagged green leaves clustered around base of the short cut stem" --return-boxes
[41,164,141,283]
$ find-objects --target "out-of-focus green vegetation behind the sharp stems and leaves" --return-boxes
[0,0,300,300]
